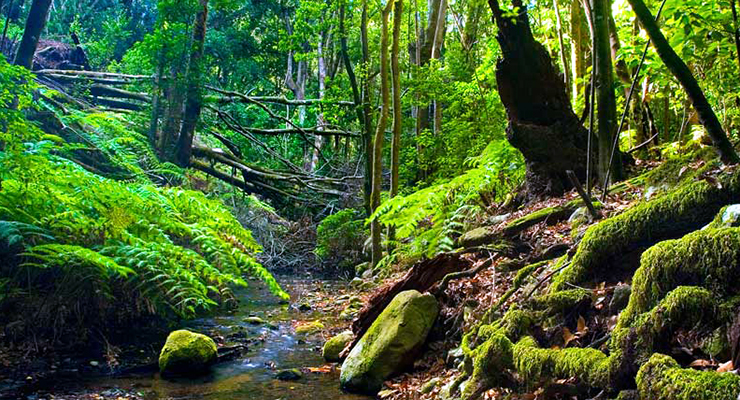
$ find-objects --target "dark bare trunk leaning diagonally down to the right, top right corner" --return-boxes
[628,0,740,164]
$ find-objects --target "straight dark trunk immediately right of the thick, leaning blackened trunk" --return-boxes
[591,0,622,187]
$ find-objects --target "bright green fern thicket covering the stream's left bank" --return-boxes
[0,57,288,342]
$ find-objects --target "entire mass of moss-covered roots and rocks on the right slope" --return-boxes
[446,174,740,400]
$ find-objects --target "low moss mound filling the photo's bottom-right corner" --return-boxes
[636,354,740,400]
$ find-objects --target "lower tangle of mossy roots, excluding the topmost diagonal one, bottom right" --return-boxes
[458,222,740,400]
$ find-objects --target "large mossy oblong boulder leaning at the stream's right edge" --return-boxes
[340,290,439,394]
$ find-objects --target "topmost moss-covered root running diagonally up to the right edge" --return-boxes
[552,174,740,291]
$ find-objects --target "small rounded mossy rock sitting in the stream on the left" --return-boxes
[159,329,218,375]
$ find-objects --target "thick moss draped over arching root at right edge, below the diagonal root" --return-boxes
[620,228,740,327]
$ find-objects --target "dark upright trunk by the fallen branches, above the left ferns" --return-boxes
[177,0,208,167]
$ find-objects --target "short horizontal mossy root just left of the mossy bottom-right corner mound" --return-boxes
[514,337,610,388]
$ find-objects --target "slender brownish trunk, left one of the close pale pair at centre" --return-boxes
[370,0,394,267]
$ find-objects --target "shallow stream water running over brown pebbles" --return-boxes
[37,280,367,400]
